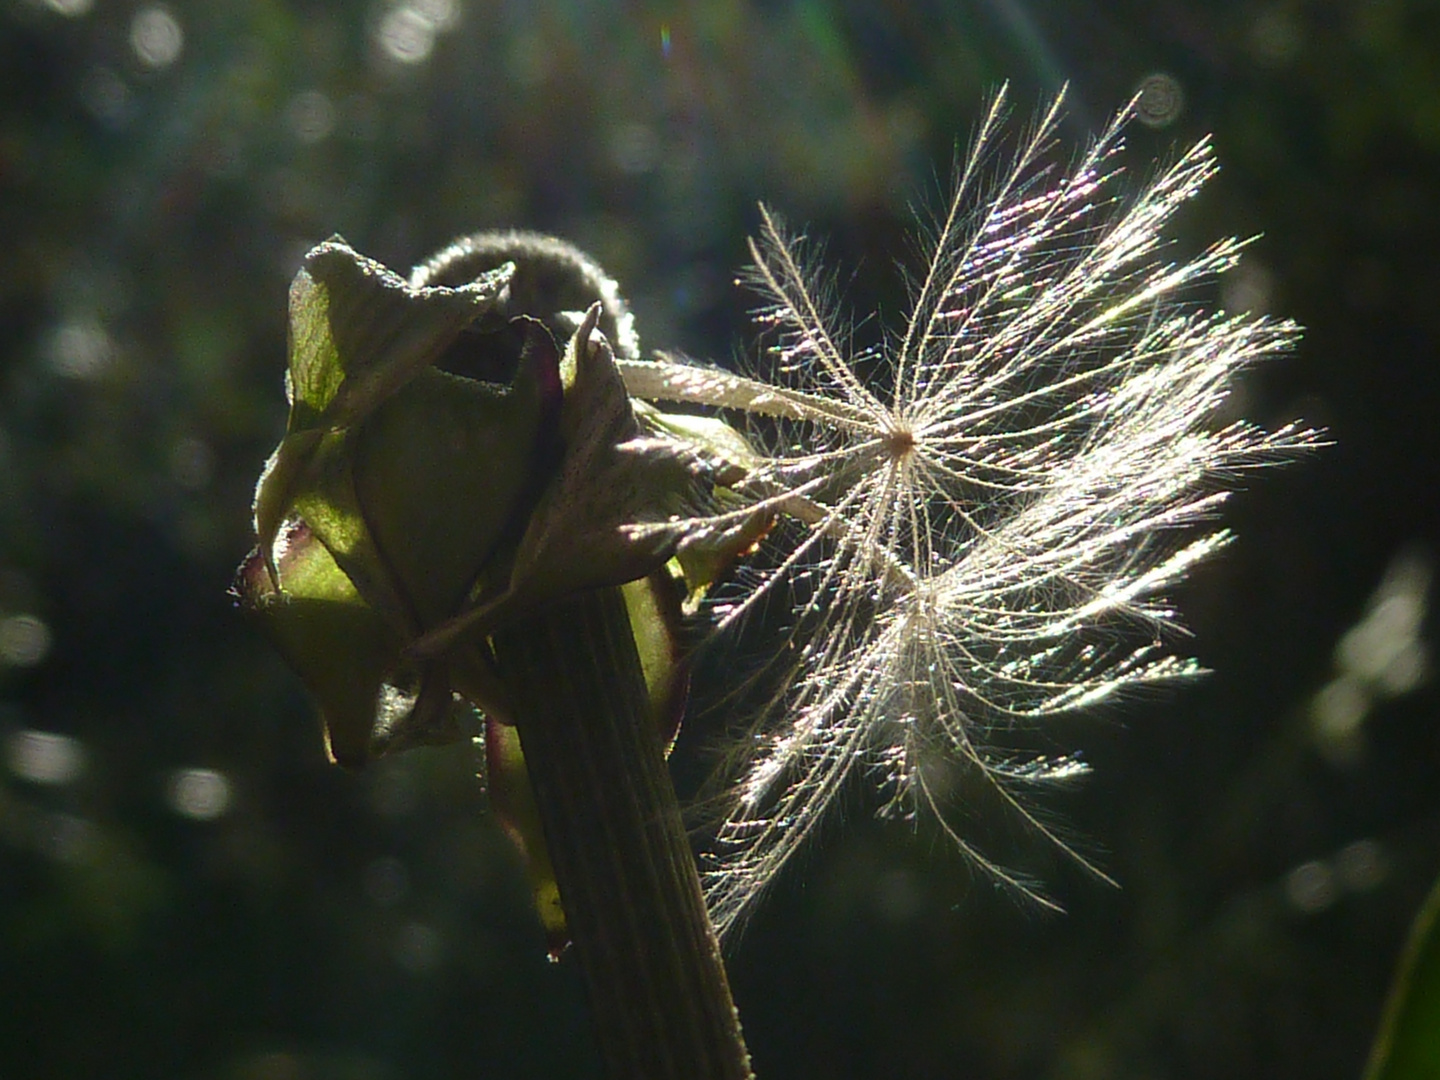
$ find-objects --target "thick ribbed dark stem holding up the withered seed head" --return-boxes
[492,588,752,1080]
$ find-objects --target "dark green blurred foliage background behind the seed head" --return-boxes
[0,0,1440,1080]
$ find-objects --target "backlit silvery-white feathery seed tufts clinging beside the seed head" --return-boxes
[624,91,1318,932]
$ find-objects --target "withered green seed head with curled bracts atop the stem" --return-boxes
[236,233,756,949]
